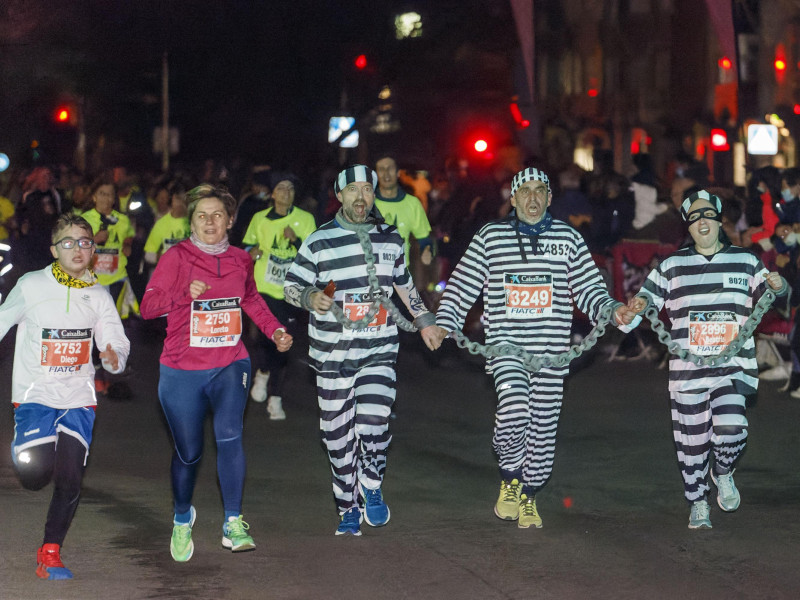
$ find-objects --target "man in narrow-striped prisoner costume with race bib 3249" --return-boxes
[437,168,633,528]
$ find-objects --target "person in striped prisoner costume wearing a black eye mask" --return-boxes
[629,190,789,529]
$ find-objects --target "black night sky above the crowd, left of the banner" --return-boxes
[0,0,516,171]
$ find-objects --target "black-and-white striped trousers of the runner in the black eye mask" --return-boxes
[670,376,747,502]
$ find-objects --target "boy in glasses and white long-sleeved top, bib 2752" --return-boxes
[0,214,130,579]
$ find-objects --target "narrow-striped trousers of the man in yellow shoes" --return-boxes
[492,360,564,492]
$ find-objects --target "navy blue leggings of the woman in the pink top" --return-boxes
[158,358,250,514]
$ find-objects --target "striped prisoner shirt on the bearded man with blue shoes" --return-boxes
[284,220,417,375]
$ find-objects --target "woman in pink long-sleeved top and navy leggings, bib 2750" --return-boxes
[141,185,292,562]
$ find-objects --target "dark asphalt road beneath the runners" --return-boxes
[0,323,800,600]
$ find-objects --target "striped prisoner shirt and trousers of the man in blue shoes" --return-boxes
[284,220,427,515]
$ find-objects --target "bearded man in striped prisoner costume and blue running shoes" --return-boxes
[284,165,441,535]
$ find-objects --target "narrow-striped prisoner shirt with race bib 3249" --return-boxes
[437,220,615,371]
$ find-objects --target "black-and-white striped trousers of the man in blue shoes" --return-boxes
[317,365,396,514]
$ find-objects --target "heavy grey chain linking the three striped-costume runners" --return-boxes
[324,228,776,373]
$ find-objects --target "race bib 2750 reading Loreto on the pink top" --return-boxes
[189,298,242,348]
